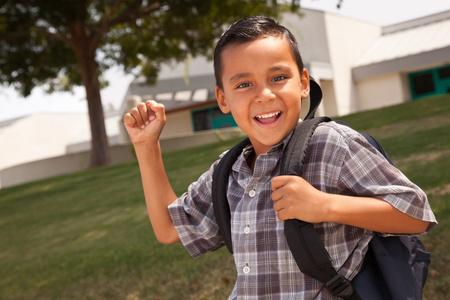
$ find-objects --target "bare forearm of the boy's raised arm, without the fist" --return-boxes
[135,143,180,244]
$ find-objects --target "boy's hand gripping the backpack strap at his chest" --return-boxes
[272,176,326,223]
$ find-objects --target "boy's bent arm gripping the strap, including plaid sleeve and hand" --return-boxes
[272,122,437,234]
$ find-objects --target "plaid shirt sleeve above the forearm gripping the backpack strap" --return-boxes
[306,122,437,233]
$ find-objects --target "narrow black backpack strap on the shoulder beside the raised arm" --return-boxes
[211,138,250,253]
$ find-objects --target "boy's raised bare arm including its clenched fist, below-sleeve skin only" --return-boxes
[124,101,180,244]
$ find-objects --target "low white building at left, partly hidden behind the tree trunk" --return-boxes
[0,112,134,188]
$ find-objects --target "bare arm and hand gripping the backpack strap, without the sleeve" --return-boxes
[272,176,429,234]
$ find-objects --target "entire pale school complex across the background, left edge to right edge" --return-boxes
[0,9,450,188]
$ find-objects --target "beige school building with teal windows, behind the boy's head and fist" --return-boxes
[120,9,450,141]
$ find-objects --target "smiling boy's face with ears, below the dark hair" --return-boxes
[216,37,309,155]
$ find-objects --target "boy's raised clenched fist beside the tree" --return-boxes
[123,100,166,146]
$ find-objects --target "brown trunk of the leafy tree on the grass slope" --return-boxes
[74,34,111,168]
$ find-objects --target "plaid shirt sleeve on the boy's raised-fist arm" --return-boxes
[168,161,224,258]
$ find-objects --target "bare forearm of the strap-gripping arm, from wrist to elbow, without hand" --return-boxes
[325,194,429,234]
